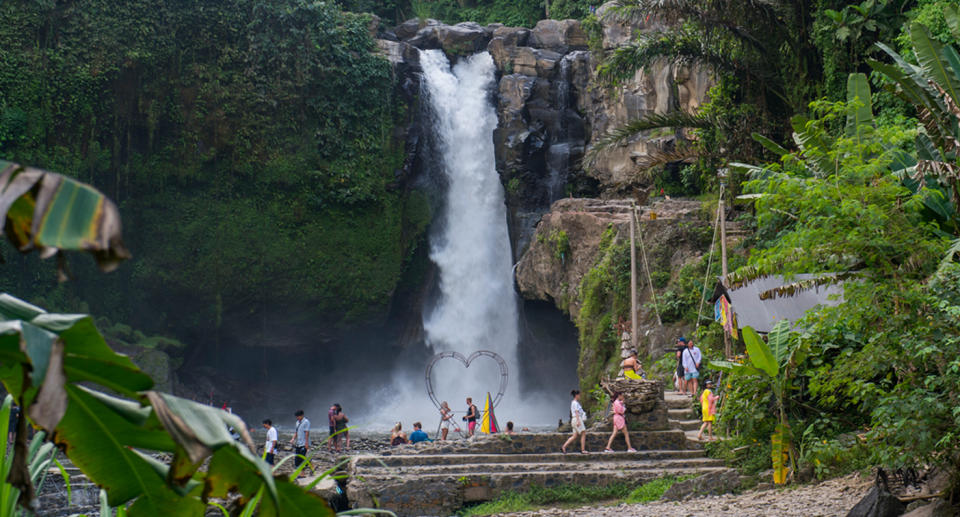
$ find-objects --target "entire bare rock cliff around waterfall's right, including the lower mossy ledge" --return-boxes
[378,6,712,396]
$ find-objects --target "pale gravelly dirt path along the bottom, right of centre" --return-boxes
[503,474,872,517]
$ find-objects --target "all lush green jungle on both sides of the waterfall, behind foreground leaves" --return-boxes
[0,0,960,510]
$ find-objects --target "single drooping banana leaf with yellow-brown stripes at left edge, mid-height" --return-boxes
[0,160,130,271]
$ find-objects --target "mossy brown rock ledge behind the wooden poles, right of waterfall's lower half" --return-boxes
[517,199,735,412]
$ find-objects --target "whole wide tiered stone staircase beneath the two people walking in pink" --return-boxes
[347,429,726,516]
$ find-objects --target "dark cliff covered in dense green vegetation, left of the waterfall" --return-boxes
[0,0,430,349]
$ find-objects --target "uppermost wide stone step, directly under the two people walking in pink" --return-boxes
[395,430,689,454]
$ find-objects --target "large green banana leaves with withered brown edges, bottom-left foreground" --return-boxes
[0,295,333,517]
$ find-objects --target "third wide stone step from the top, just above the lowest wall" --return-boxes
[362,453,723,477]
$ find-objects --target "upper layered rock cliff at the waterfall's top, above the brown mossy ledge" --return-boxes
[377,8,711,259]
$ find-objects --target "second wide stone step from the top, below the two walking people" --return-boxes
[353,448,705,468]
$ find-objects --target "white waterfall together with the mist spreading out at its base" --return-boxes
[354,50,576,430]
